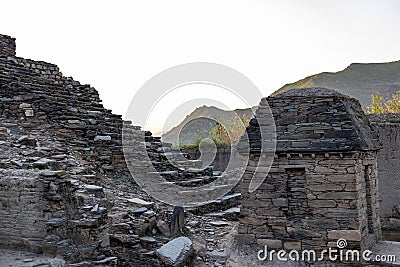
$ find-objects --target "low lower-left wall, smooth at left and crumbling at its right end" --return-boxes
[0,169,109,261]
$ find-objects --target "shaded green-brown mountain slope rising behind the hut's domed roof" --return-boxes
[272,61,400,107]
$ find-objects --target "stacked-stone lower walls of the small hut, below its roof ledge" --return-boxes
[239,153,379,253]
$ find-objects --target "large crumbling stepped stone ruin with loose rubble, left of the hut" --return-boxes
[0,35,240,266]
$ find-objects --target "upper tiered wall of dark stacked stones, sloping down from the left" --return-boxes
[0,38,136,178]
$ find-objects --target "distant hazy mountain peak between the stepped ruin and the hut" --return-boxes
[161,106,253,146]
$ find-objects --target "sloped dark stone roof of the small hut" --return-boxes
[247,88,380,153]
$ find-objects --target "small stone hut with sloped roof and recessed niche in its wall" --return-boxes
[238,88,381,251]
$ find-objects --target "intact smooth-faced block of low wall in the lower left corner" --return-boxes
[0,170,46,252]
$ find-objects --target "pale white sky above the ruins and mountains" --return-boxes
[0,0,400,134]
